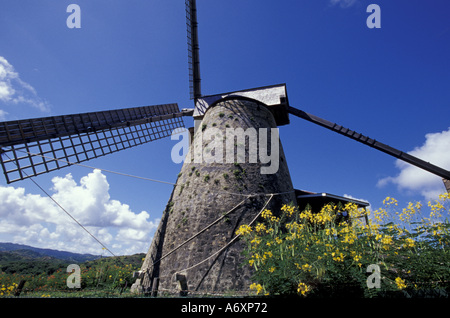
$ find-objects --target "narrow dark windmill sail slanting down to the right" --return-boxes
[288,106,450,180]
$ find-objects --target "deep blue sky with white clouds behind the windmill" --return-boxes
[0,0,450,254]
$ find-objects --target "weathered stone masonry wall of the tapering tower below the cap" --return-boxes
[134,100,295,293]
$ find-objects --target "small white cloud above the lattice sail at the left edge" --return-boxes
[0,56,50,116]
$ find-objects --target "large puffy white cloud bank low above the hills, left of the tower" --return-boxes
[0,170,159,255]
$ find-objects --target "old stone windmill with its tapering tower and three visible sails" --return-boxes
[0,0,450,293]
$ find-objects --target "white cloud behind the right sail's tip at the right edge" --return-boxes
[378,128,450,200]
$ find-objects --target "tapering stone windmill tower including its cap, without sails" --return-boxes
[135,85,296,293]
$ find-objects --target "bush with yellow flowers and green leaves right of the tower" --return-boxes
[236,194,450,297]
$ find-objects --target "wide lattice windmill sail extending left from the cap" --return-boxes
[0,104,192,183]
